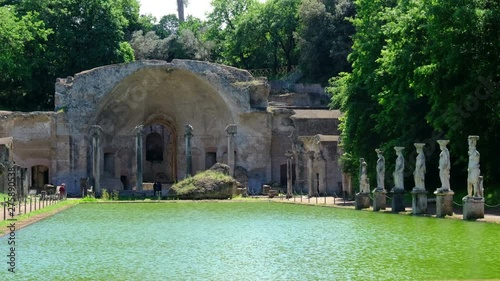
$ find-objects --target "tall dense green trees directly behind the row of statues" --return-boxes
[330,0,500,189]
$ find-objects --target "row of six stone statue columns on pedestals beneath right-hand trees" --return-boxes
[355,136,484,219]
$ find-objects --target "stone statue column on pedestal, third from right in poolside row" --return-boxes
[411,143,427,215]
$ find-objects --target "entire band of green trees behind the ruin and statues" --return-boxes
[0,0,500,194]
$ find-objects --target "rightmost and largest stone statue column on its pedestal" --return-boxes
[462,136,484,220]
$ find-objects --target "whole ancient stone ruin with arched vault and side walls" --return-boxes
[0,60,342,196]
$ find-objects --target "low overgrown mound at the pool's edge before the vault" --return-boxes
[172,164,238,200]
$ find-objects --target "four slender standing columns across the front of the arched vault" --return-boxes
[90,124,238,193]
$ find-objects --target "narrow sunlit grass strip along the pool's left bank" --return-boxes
[0,200,80,237]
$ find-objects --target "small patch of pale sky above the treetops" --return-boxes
[139,0,211,20]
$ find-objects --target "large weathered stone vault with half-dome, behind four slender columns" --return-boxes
[56,60,271,189]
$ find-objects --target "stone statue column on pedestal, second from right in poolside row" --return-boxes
[434,140,455,218]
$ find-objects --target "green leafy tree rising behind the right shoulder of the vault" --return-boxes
[207,0,300,72]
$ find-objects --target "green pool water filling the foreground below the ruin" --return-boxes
[0,202,500,280]
